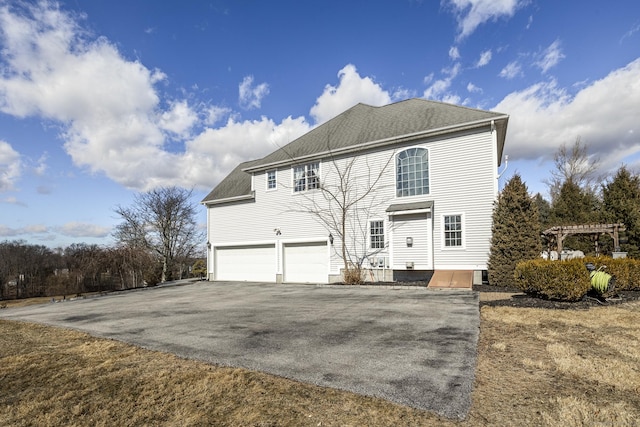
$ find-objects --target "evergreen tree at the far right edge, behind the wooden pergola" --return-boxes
[602,166,640,258]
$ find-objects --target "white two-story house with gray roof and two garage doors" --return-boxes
[202,99,509,283]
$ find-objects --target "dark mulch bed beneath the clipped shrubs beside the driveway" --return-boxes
[473,285,640,310]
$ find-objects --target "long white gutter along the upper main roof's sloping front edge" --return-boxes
[242,114,509,173]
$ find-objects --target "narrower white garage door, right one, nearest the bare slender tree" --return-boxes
[283,242,329,283]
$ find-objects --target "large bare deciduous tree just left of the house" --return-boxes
[114,187,204,282]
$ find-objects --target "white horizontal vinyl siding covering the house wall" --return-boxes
[208,126,497,280]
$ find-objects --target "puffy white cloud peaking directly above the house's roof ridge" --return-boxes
[310,64,391,124]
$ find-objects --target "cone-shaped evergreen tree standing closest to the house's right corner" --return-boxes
[489,174,542,286]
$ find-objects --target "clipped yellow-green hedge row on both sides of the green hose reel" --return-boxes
[514,257,640,301]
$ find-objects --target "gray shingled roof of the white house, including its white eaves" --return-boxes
[202,98,508,203]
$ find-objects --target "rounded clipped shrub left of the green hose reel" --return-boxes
[514,259,591,301]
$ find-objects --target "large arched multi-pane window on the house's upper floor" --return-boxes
[396,147,429,197]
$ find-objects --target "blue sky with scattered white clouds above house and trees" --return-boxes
[0,0,640,247]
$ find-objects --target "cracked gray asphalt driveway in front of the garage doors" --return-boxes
[0,282,479,418]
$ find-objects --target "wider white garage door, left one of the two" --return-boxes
[215,245,276,282]
